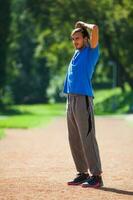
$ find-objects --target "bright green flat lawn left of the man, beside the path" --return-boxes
[0,104,65,128]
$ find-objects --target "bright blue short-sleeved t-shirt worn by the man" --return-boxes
[63,45,99,96]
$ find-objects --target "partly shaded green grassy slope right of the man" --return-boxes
[94,88,133,115]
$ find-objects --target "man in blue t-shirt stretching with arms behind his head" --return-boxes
[64,21,103,187]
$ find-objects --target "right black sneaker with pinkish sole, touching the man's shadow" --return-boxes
[82,176,103,188]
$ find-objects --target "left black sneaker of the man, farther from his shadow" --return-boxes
[67,173,89,185]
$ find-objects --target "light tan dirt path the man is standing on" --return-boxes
[0,117,133,200]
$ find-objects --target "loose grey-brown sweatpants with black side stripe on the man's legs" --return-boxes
[67,94,102,175]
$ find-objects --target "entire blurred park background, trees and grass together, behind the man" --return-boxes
[0,0,133,137]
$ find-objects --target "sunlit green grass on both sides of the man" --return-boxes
[0,88,133,129]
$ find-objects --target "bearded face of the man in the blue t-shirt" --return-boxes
[72,32,87,49]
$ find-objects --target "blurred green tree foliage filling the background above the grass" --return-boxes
[0,0,133,104]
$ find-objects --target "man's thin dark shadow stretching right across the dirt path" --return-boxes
[99,187,133,196]
